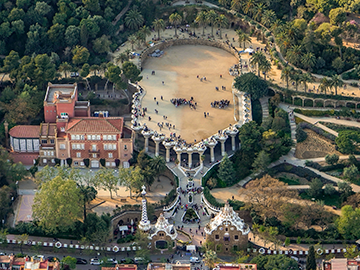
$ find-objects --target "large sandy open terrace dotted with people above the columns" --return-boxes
[140,45,237,143]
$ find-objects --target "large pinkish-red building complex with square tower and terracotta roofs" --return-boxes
[9,83,134,168]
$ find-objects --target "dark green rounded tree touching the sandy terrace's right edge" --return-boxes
[234,72,268,100]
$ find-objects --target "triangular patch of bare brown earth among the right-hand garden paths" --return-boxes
[295,129,341,159]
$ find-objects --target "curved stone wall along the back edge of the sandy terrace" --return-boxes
[139,38,239,69]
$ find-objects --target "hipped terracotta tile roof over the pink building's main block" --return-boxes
[65,117,123,134]
